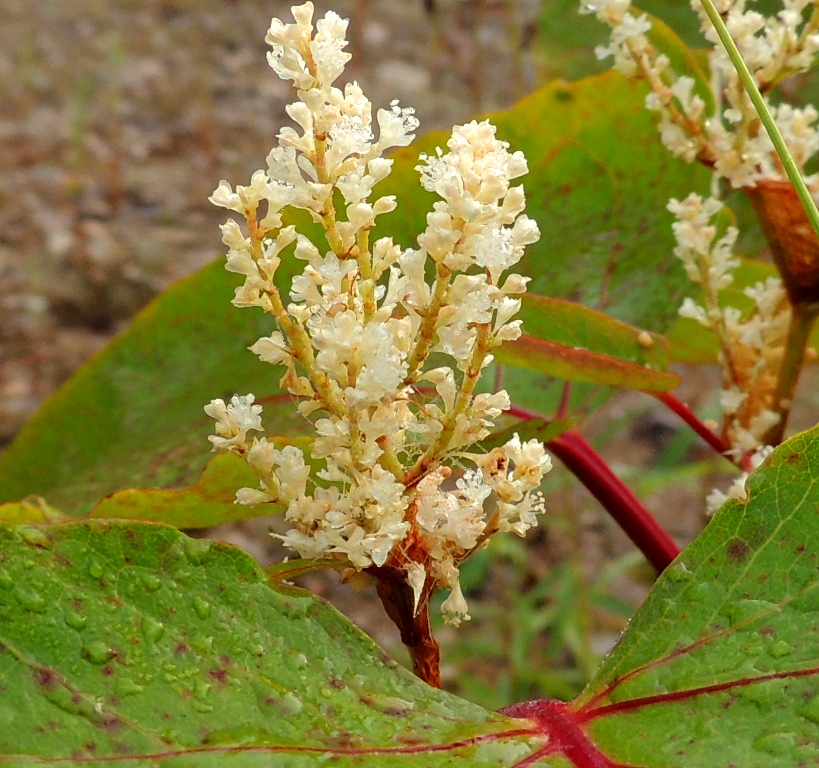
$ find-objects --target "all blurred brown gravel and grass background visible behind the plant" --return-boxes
[0,0,815,708]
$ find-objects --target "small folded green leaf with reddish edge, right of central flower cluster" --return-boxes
[495,294,680,392]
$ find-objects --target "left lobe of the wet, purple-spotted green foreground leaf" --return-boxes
[0,522,544,768]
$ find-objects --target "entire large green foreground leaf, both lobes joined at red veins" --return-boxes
[0,428,819,768]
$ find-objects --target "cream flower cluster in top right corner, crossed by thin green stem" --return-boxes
[580,0,819,188]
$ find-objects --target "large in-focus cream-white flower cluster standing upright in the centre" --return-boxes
[205,2,551,624]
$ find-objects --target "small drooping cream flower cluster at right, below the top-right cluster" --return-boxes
[668,194,791,459]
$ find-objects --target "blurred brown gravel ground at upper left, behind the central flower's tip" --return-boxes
[0,0,552,442]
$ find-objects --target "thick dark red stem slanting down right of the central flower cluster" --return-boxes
[506,406,680,573]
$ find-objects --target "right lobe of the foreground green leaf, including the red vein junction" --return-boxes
[505,428,819,768]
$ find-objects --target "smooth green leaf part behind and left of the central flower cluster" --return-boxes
[0,260,309,519]
